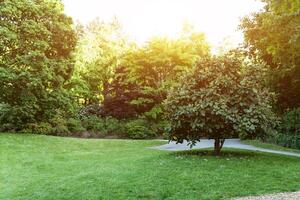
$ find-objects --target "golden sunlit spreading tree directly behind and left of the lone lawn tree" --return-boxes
[122,32,210,113]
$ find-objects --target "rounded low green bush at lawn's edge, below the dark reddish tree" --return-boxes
[125,119,156,139]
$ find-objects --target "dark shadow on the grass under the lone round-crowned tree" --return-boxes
[172,148,262,158]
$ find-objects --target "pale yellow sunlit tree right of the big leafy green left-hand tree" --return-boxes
[74,18,128,105]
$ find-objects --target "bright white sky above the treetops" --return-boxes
[62,0,264,47]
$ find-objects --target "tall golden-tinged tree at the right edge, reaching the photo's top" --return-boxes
[241,0,300,111]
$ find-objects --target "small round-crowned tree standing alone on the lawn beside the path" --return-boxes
[165,54,276,155]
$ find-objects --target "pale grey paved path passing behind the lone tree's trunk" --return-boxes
[152,139,300,157]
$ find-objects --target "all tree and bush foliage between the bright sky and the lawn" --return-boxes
[0,0,300,147]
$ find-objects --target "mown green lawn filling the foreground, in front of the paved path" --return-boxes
[0,134,300,200]
